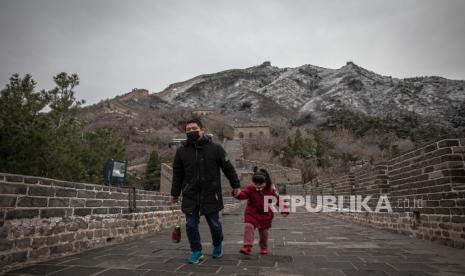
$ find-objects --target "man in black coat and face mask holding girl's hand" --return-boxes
[171,119,241,264]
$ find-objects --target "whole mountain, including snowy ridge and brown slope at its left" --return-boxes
[79,62,465,170]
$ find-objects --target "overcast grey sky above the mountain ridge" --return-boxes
[0,0,465,103]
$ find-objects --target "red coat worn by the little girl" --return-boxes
[236,184,287,228]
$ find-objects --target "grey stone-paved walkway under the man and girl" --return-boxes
[6,206,465,276]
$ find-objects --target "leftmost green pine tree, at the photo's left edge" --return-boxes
[0,74,48,175]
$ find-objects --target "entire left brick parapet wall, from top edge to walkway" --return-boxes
[0,173,183,272]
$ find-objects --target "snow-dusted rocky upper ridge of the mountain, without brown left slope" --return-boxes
[155,62,465,124]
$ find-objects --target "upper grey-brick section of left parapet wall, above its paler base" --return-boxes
[0,174,169,220]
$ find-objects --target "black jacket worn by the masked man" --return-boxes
[171,136,240,214]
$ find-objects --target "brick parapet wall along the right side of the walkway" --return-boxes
[303,139,465,248]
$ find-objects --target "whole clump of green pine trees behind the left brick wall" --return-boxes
[0,73,125,183]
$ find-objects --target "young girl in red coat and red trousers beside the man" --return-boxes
[232,167,289,256]
